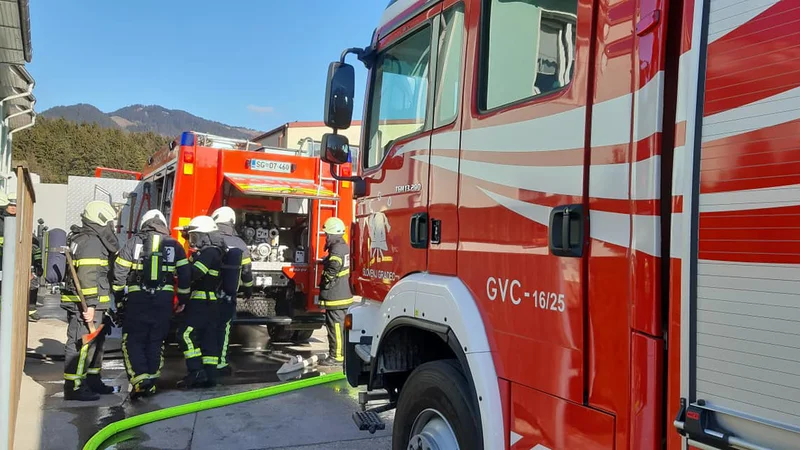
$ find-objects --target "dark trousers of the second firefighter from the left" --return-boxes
[122,291,173,386]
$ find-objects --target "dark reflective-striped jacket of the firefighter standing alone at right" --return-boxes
[319,235,353,309]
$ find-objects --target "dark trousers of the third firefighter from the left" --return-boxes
[179,299,219,382]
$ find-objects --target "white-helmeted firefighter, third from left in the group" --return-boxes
[176,216,224,388]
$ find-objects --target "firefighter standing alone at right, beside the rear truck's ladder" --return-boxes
[319,217,353,366]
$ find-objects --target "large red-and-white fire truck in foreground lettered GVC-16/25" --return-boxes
[322,0,800,450]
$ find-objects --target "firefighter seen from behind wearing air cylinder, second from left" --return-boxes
[112,209,191,400]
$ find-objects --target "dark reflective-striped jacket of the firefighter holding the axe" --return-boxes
[61,220,119,309]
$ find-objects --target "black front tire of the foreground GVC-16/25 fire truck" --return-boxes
[392,360,483,450]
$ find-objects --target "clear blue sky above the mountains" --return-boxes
[28,0,388,131]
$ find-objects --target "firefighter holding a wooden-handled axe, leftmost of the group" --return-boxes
[61,200,119,401]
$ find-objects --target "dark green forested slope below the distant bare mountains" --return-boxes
[12,117,170,183]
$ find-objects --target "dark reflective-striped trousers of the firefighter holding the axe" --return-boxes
[64,309,106,390]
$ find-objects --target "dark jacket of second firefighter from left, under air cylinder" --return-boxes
[112,219,191,300]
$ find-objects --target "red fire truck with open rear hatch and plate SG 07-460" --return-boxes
[108,131,353,342]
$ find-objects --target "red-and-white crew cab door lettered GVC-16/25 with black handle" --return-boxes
[456,0,593,404]
